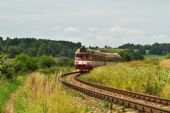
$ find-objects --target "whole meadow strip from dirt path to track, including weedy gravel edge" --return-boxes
[14,69,110,113]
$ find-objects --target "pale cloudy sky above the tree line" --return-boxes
[0,0,170,47]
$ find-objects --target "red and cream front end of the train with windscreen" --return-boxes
[75,48,93,71]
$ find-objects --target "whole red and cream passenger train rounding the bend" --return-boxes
[75,47,122,71]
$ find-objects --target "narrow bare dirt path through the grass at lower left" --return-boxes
[5,91,17,113]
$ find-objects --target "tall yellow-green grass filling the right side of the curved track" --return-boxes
[82,61,170,98]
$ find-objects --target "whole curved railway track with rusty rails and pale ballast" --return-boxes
[61,72,170,113]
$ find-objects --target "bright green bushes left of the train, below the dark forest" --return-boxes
[1,54,74,80]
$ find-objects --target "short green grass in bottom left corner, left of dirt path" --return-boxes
[0,78,21,112]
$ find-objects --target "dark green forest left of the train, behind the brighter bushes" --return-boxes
[0,37,81,58]
